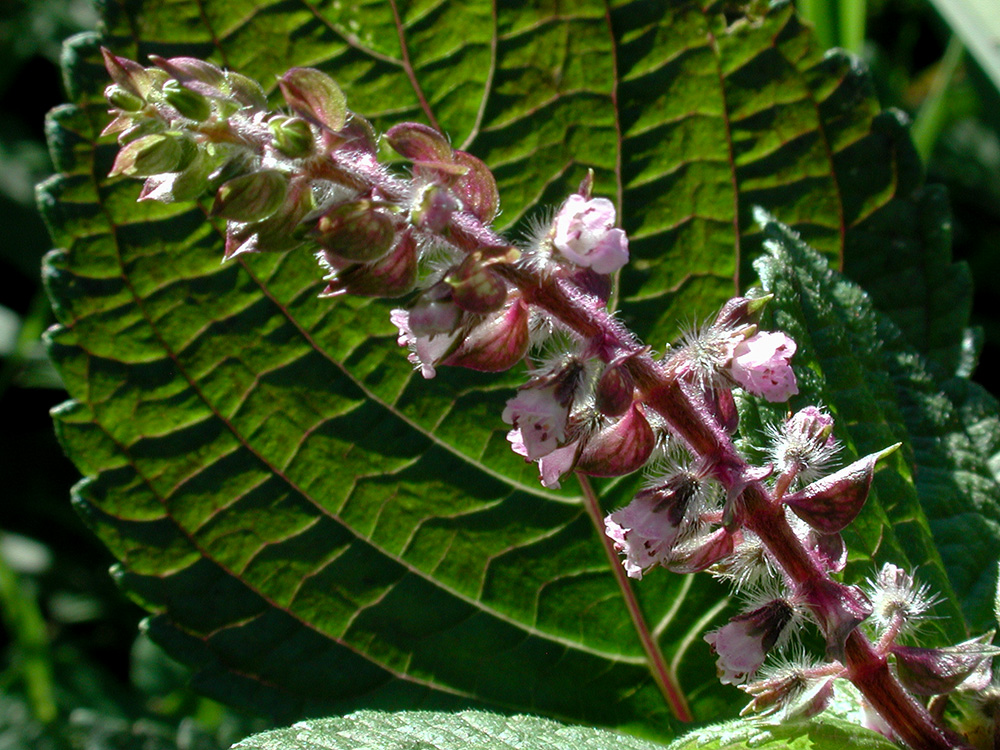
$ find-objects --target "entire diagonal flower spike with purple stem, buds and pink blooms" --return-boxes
[105,52,984,748]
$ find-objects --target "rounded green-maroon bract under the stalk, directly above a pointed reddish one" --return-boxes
[312,200,396,263]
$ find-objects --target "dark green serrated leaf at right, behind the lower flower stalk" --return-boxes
[756,217,1000,642]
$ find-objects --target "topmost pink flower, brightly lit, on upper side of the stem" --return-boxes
[552,193,628,273]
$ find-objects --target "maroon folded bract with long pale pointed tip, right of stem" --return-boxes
[783,443,900,534]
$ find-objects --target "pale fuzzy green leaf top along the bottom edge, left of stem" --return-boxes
[233,711,663,750]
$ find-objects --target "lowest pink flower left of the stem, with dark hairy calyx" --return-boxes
[705,599,795,685]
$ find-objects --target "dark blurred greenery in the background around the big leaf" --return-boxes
[0,0,1000,750]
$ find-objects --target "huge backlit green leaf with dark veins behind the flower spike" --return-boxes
[40,0,992,735]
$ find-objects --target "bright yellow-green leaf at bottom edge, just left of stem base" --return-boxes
[668,715,899,750]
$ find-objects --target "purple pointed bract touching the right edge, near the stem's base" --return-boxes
[890,632,1000,695]
